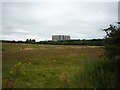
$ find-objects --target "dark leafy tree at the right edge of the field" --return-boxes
[104,25,120,59]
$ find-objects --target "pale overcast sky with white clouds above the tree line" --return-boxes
[1,0,118,41]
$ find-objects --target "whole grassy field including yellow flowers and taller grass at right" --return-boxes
[2,43,116,88]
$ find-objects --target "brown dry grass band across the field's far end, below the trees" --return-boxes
[2,43,103,61]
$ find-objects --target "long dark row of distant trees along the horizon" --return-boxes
[2,39,104,46]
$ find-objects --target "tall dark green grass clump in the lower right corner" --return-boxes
[75,58,120,88]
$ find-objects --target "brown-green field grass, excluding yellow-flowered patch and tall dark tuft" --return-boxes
[2,43,103,87]
